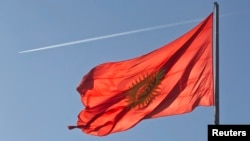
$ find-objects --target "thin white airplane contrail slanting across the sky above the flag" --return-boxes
[18,19,202,53]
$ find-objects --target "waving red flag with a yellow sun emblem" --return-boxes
[69,13,214,136]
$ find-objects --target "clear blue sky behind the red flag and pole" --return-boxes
[0,0,250,141]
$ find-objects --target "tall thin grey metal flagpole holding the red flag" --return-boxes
[213,2,220,125]
